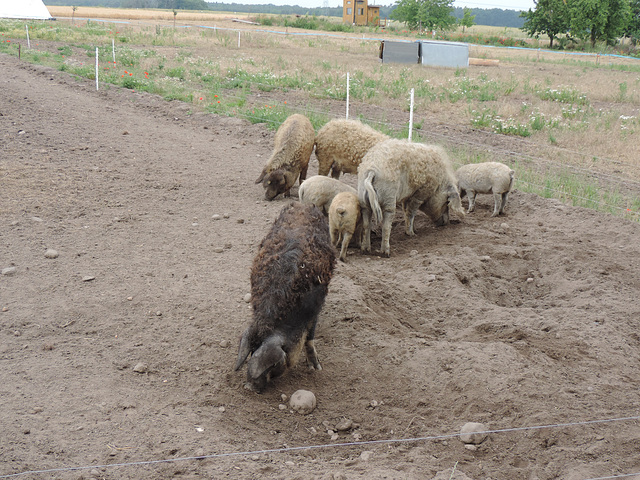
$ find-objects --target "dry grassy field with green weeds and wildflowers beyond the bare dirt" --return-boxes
[0,7,640,218]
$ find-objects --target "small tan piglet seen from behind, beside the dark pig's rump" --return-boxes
[329,192,362,262]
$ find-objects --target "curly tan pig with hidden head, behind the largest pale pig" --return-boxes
[316,119,389,178]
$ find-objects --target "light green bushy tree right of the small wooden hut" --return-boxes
[391,0,456,30]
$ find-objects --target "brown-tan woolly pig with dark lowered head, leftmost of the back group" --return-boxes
[256,113,315,200]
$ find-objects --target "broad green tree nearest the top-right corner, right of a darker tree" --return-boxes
[571,0,631,48]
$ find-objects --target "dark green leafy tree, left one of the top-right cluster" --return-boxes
[520,0,571,48]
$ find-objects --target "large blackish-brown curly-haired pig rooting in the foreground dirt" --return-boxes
[235,202,336,393]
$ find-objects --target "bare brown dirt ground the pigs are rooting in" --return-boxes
[0,55,640,480]
